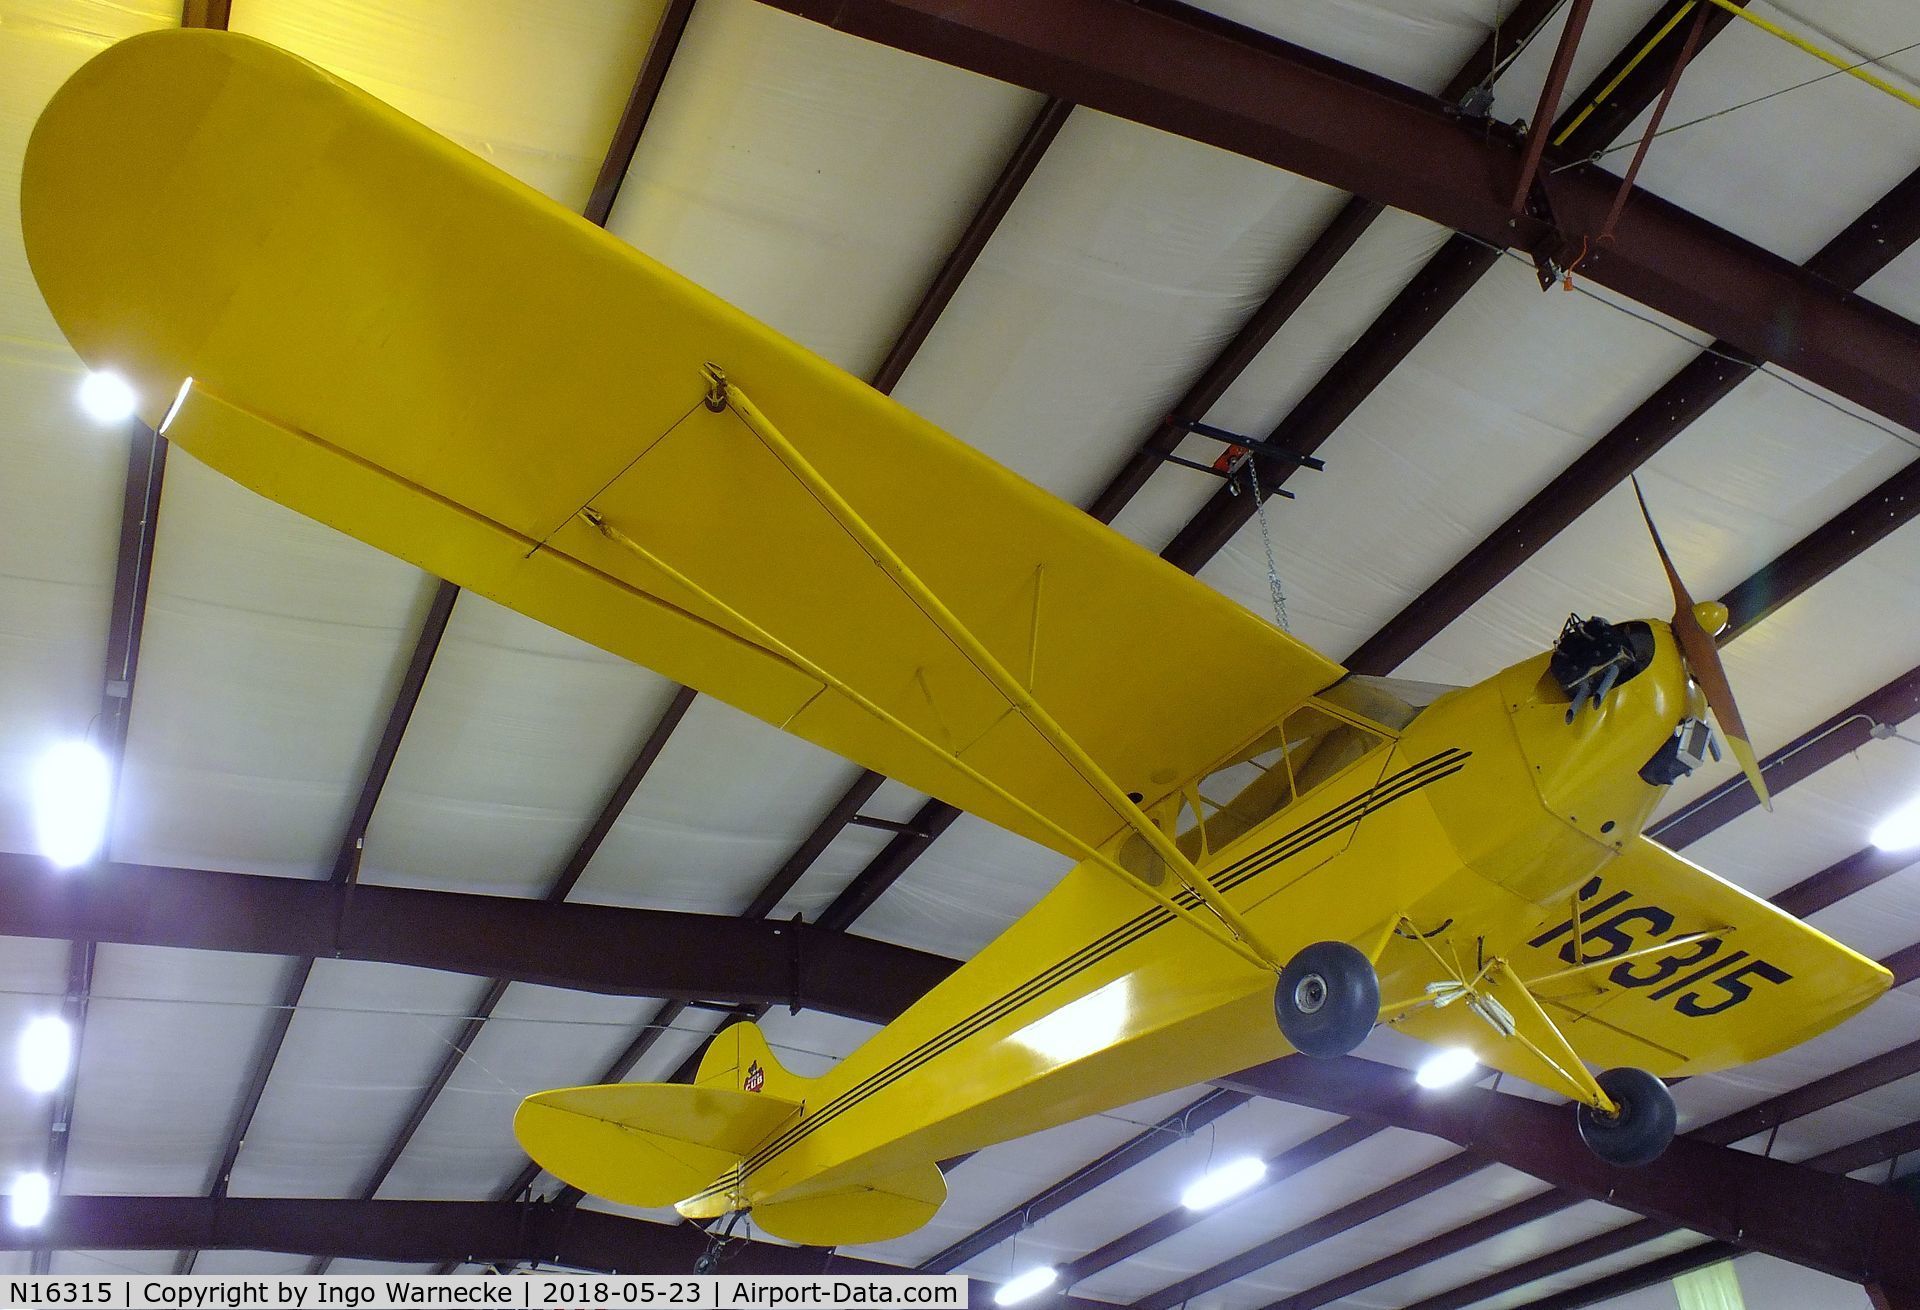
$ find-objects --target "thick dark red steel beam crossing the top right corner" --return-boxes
[756,0,1920,426]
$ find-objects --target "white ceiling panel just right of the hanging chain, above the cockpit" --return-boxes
[1200,259,1693,656]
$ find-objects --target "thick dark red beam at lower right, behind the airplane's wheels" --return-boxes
[1221,1056,1920,1285]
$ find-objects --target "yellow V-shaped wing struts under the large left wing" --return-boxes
[582,365,1284,972]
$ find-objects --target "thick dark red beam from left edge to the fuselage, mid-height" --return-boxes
[0,853,956,1022]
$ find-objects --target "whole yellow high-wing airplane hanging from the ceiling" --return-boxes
[21,31,1889,1245]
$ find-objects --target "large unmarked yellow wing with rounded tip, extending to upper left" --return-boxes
[21,31,1340,849]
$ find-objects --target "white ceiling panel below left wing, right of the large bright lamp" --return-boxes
[111,451,432,878]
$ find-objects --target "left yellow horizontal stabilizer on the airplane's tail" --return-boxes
[513,1083,801,1206]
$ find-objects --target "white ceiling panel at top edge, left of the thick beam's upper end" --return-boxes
[607,0,1041,378]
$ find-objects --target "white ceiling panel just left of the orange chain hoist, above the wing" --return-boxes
[895,109,1346,505]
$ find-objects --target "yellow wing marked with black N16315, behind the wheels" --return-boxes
[1405,837,1893,1081]
